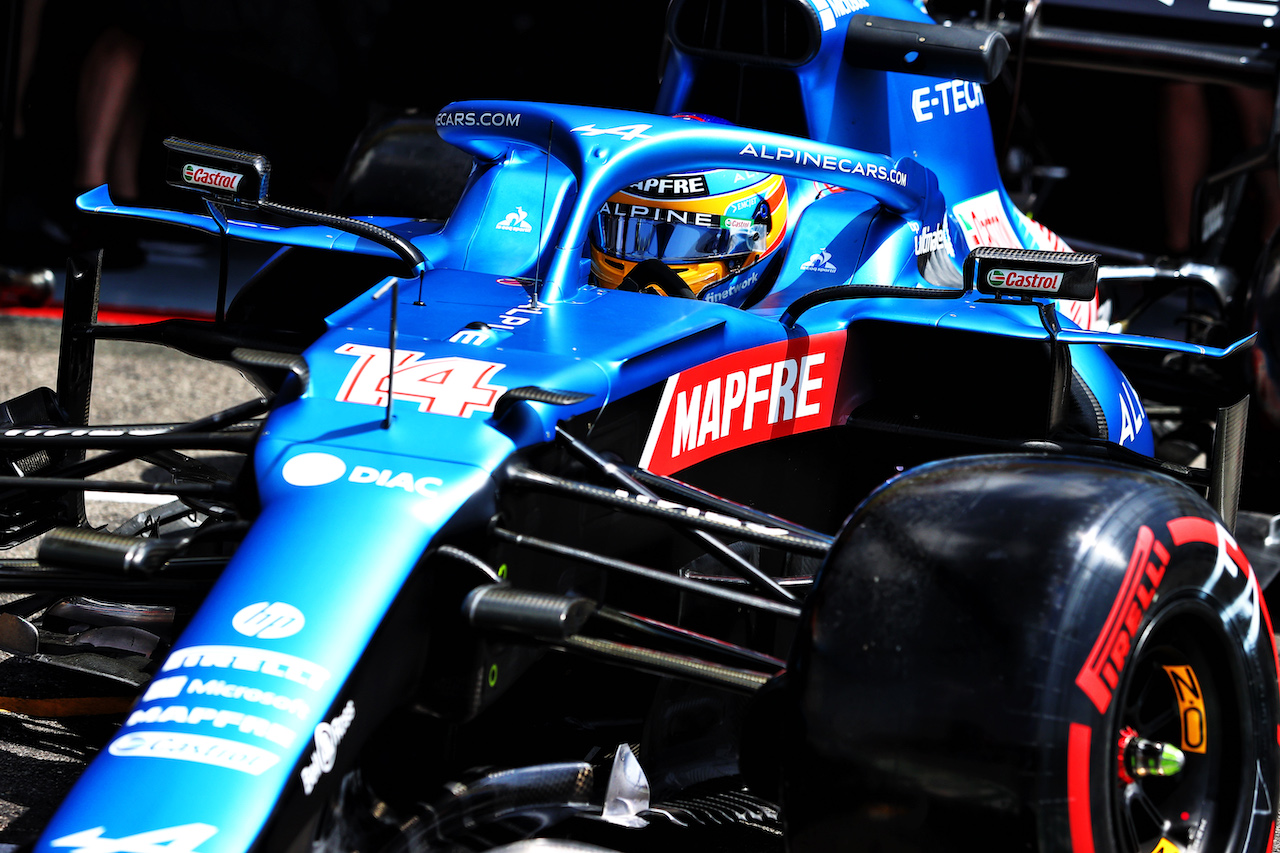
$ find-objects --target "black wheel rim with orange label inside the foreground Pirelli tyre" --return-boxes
[1107,602,1257,853]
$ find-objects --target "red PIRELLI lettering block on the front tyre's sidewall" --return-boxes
[1075,525,1169,713]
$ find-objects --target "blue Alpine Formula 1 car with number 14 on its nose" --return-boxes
[0,0,1280,853]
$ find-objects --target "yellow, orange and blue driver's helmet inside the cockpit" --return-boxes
[591,169,787,306]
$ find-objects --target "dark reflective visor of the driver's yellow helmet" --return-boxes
[591,204,769,264]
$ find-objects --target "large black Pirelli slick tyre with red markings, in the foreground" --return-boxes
[769,456,1280,853]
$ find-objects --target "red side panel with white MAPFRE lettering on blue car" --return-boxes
[640,332,852,474]
